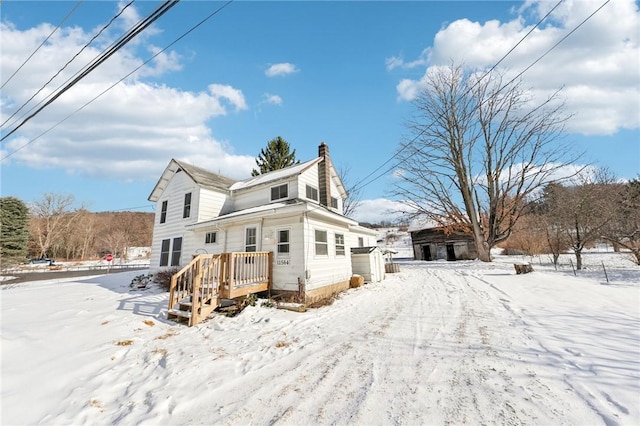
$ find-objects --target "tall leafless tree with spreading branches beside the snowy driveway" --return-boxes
[394,65,577,262]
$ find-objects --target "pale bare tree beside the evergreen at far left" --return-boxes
[29,193,79,257]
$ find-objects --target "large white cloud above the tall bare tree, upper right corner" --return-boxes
[396,0,640,135]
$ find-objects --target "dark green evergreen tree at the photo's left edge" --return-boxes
[0,197,29,265]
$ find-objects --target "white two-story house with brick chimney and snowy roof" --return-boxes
[149,142,376,303]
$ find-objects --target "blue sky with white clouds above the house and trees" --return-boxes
[0,0,640,221]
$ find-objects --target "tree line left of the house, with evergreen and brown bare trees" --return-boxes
[0,193,155,266]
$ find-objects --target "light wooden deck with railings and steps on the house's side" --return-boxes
[167,252,273,326]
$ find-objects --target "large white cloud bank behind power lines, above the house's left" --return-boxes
[0,5,255,181]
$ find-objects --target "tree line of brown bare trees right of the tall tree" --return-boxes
[504,174,640,269]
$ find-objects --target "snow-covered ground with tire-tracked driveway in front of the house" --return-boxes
[0,253,640,425]
